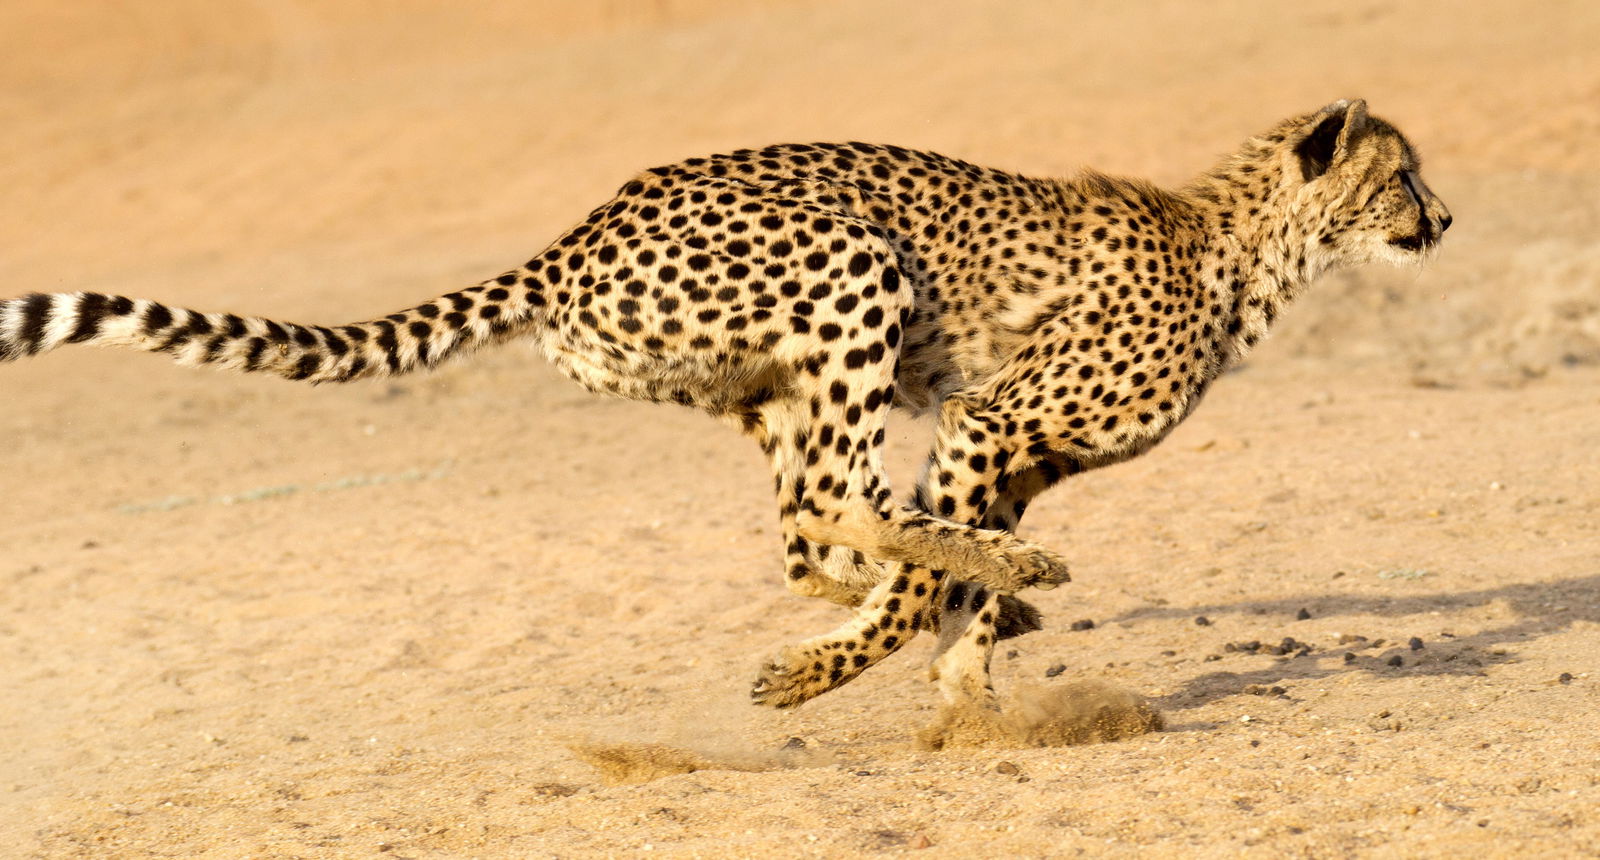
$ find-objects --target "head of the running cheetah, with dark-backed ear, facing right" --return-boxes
[1283,99,1450,264]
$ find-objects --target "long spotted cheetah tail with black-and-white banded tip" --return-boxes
[0,273,544,382]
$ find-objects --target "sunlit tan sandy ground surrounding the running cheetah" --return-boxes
[0,0,1600,857]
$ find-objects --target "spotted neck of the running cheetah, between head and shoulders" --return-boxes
[1182,145,1328,369]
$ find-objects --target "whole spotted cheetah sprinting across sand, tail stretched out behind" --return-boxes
[0,99,1451,708]
